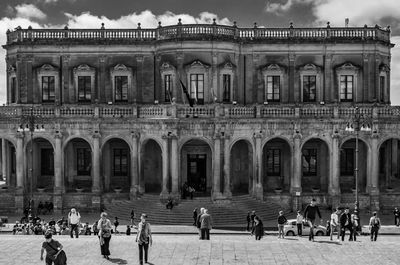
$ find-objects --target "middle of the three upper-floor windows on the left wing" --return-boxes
[74,64,96,102]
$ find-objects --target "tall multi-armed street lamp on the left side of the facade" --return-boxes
[17,107,45,211]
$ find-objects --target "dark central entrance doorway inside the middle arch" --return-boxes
[187,154,207,192]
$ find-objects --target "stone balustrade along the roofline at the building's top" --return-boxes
[7,24,390,44]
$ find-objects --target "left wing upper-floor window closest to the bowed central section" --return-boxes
[111,64,133,102]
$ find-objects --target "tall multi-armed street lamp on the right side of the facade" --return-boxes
[345,107,372,211]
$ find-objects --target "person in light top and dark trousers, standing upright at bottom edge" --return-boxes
[135,213,153,265]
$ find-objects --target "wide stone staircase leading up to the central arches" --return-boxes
[104,194,289,227]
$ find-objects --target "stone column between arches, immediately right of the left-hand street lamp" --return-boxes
[53,132,64,213]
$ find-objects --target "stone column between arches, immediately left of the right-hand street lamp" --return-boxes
[328,133,340,207]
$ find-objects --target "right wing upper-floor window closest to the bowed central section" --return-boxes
[262,64,285,102]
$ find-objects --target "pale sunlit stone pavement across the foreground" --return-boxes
[0,235,400,265]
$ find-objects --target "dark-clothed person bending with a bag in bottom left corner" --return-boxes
[40,233,67,265]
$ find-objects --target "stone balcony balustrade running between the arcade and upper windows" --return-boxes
[0,104,400,120]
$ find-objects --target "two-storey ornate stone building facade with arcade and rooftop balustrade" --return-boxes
[0,21,400,211]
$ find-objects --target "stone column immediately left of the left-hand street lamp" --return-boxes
[15,133,25,213]
